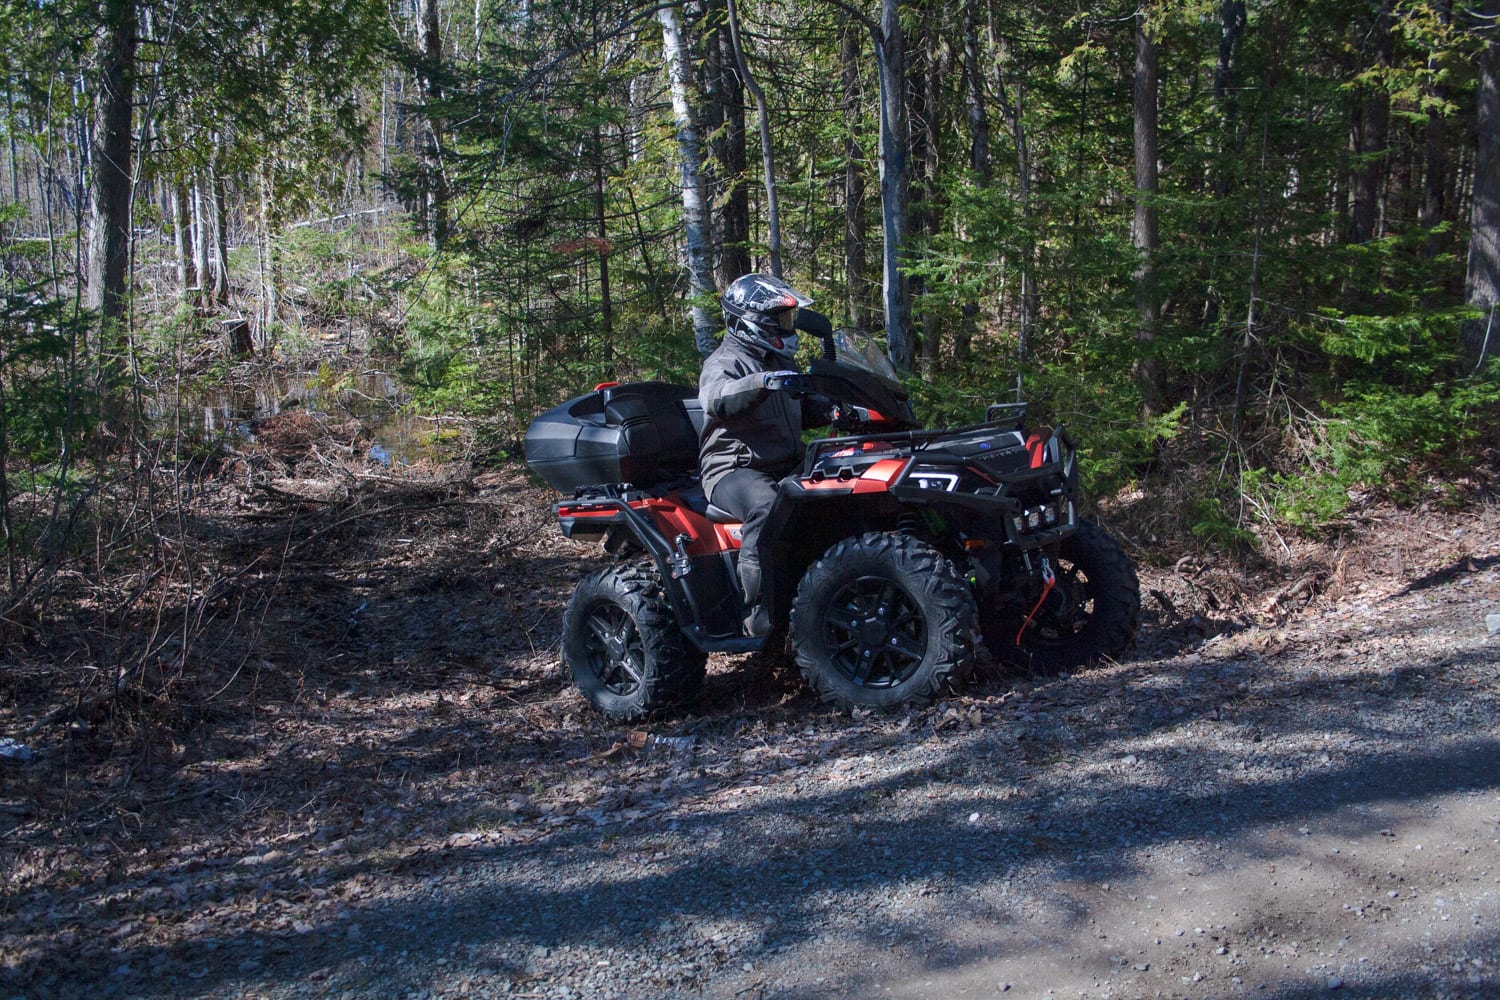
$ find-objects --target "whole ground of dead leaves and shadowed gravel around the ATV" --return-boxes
[0,407,1500,1000]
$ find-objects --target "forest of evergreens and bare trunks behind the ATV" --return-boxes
[0,0,1500,644]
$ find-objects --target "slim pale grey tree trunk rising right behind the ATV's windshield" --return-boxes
[875,0,912,369]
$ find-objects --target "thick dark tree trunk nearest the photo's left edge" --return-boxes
[86,0,137,328]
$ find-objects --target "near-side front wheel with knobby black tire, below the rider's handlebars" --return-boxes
[792,534,977,709]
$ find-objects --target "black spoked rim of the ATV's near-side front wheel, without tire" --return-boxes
[822,576,927,688]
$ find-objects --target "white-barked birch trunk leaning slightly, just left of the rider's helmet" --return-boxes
[657,1,719,357]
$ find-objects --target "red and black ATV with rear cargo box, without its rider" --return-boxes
[525,320,1140,720]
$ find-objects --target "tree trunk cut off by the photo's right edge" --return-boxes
[1463,0,1500,364]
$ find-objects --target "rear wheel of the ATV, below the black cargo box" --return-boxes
[563,565,708,720]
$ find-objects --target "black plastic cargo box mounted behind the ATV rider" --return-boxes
[525,382,704,493]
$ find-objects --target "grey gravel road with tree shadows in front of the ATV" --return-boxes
[5,497,1500,1000]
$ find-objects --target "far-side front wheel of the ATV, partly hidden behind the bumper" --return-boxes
[984,520,1140,672]
